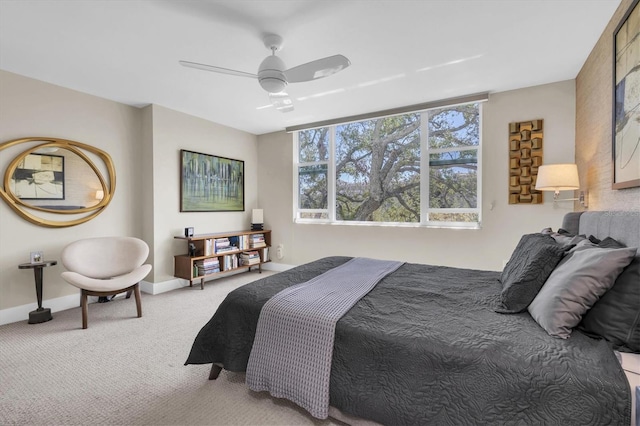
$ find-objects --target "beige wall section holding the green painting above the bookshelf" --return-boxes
[148,105,258,283]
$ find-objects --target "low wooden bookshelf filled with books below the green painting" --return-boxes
[173,230,271,289]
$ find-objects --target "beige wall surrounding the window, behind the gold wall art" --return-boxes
[258,80,575,270]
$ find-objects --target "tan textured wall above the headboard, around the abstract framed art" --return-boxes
[576,0,640,210]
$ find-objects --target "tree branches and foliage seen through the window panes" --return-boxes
[299,104,480,222]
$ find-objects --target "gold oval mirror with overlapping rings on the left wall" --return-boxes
[0,138,116,227]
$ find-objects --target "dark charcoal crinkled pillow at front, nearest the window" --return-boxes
[496,234,565,314]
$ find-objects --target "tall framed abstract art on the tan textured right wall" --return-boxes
[611,0,640,189]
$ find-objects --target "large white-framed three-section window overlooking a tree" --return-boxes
[294,103,481,227]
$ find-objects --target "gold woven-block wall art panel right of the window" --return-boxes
[509,120,543,204]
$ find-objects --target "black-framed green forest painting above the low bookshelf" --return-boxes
[180,149,244,212]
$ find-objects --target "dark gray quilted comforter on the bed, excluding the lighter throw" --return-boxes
[186,257,631,425]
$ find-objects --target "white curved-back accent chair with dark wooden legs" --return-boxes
[62,237,151,329]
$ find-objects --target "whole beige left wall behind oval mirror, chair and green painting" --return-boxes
[0,71,257,324]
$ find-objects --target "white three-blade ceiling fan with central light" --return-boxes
[179,34,351,112]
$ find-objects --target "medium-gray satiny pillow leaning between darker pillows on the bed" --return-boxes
[527,246,637,339]
